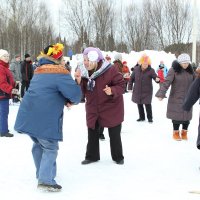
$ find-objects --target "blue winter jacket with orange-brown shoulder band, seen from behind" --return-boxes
[14,58,81,141]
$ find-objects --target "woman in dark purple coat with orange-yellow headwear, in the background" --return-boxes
[128,55,159,123]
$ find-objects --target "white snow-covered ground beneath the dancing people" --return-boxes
[0,49,200,200]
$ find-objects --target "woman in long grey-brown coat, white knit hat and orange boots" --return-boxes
[156,54,194,141]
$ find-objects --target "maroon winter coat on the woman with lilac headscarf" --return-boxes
[81,61,125,129]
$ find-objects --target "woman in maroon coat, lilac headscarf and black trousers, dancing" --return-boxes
[75,47,125,165]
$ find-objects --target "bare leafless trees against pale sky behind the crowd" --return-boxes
[0,0,199,63]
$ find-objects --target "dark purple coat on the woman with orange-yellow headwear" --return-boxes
[128,65,157,104]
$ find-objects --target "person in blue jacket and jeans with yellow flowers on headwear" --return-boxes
[14,43,81,191]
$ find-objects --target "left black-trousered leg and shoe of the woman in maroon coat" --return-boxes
[82,122,100,164]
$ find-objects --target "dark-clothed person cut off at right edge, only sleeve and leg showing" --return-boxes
[183,77,200,149]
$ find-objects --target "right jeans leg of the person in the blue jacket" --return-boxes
[37,138,59,185]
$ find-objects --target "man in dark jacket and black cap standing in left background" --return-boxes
[21,54,33,98]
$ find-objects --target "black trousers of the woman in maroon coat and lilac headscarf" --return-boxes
[85,122,124,161]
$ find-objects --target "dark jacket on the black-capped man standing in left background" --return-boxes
[21,60,33,81]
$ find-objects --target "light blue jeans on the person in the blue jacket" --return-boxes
[31,137,59,185]
